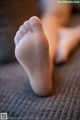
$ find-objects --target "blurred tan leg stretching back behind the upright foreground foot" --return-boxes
[39,0,72,60]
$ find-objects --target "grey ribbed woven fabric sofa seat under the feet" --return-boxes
[0,49,80,120]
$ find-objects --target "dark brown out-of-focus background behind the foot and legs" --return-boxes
[0,0,80,64]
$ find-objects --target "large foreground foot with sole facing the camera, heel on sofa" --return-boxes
[14,17,52,96]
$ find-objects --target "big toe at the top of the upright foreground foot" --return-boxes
[29,16,42,32]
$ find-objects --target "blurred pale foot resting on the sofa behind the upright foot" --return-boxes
[55,27,80,64]
